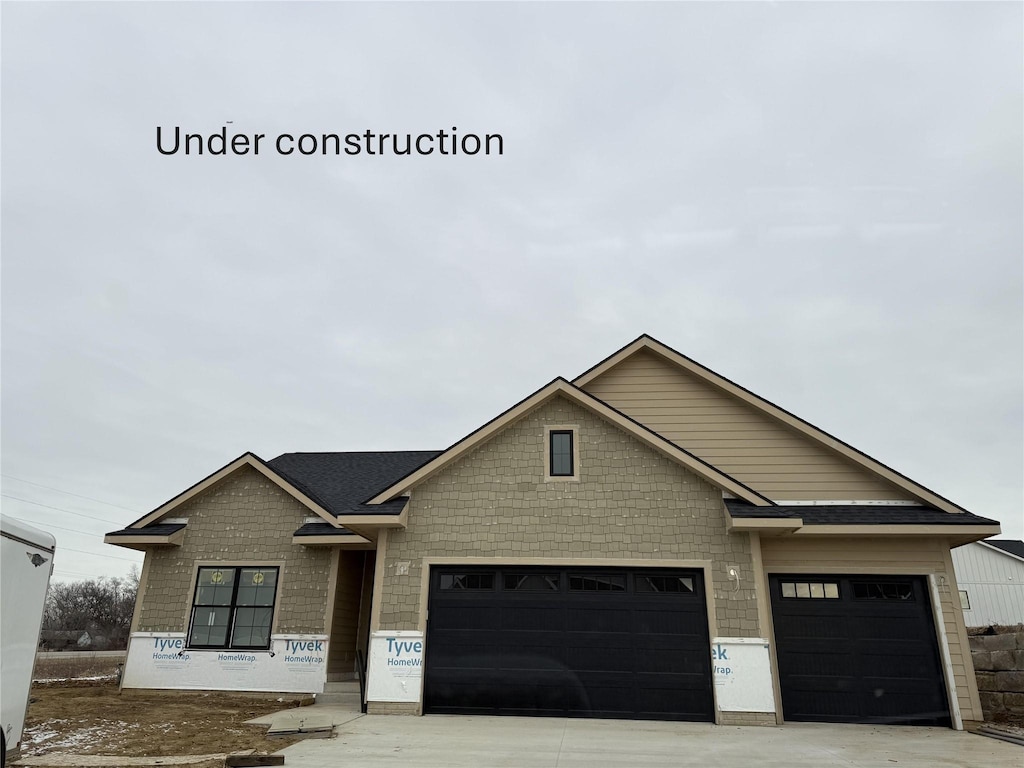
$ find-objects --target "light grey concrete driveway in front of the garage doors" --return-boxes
[284,715,1024,768]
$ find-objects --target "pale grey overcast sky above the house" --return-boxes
[2,3,1024,580]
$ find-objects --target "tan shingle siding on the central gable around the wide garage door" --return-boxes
[381,397,758,637]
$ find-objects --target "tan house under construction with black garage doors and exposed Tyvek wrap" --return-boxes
[106,336,999,728]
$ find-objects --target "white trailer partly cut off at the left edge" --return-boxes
[0,515,56,765]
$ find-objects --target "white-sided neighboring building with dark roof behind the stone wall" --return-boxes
[953,539,1024,627]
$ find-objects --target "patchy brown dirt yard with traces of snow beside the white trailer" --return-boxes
[22,679,299,757]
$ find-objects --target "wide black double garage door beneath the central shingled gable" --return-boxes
[424,567,714,721]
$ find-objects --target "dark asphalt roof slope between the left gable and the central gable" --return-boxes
[267,451,440,515]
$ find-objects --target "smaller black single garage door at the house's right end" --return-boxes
[770,574,949,725]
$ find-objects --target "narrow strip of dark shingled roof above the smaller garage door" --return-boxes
[725,499,999,528]
